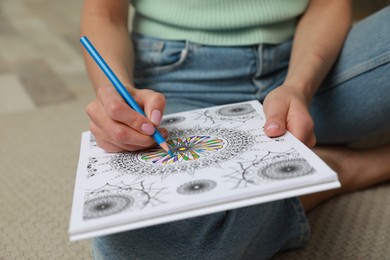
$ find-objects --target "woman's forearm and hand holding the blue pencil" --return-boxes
[81,0,167,152]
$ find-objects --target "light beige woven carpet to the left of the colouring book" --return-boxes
[0,98,91,259]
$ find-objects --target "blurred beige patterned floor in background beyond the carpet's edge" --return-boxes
[0,0,390,113]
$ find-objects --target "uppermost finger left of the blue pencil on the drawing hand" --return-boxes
[97,86,155,135]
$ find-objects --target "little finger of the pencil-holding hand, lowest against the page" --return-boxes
[90,122,154,153]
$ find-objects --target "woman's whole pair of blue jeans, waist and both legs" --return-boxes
[92,8,390,259]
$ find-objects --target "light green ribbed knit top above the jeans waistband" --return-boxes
[132,0,308,46]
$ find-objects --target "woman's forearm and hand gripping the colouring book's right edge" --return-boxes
[264,0,352,147]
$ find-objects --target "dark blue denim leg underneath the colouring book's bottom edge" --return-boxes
[92,199,309,260]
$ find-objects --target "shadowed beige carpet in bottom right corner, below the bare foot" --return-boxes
[275,184,390,260]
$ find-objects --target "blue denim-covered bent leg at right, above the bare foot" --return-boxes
[310,7,390,143]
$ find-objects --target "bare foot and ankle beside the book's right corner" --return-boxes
[300,144,390,211]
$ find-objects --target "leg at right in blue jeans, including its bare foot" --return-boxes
[300,7,390,211]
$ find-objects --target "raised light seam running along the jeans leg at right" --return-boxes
[317,52,390,94]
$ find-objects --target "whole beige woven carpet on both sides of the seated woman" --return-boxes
[0,95,390,260]
